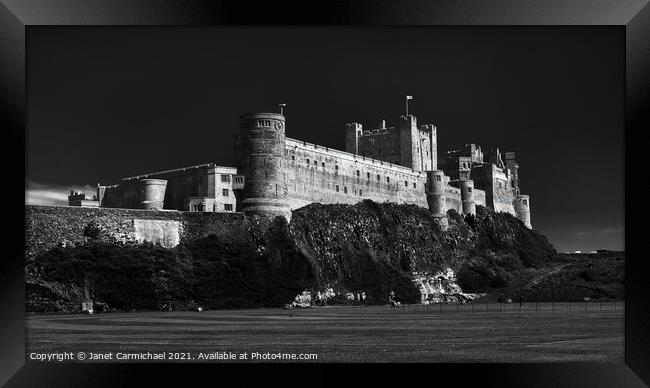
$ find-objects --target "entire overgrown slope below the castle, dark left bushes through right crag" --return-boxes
[25,201,557,311]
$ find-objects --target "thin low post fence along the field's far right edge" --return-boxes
[390,301,625,314]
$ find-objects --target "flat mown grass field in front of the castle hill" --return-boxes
[26,303,624,362]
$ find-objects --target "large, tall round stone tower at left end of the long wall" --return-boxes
[238,113,291,219]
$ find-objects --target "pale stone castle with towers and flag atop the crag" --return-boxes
[69,109,532,228]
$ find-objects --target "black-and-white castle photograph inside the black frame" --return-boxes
[25,26,625,363]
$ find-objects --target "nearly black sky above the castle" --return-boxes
[27,27,625,251]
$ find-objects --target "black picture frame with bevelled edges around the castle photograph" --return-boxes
[0,0,650,387]
